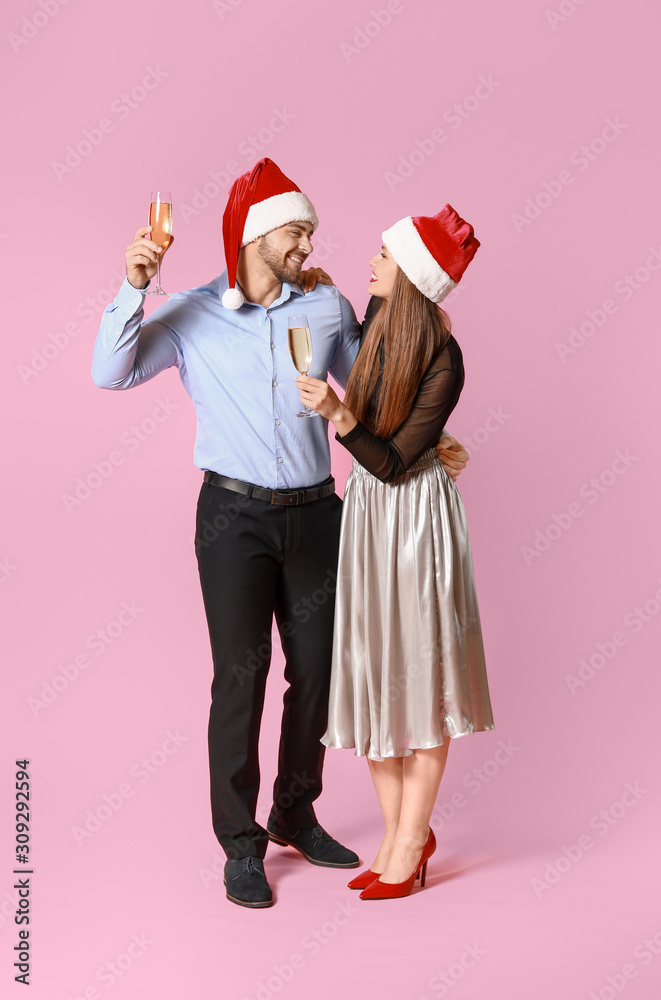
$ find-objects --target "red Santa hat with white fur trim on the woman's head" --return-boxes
[382,205,480,302]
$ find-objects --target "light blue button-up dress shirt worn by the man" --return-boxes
[92,271,360,489]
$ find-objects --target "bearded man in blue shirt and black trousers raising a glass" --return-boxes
[92,158,468,907]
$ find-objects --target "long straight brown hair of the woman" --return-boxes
[344,267,450,438]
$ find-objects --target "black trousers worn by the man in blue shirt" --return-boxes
[195,483,342,859]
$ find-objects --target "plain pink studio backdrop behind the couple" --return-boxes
[0,0,661,1000]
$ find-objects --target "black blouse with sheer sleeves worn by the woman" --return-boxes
[335,295,464,483]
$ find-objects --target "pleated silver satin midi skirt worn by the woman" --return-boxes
[321,449,494,760]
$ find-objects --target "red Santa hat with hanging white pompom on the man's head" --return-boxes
[222,157,319,309]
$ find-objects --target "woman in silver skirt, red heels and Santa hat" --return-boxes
[297,205,494,899]
